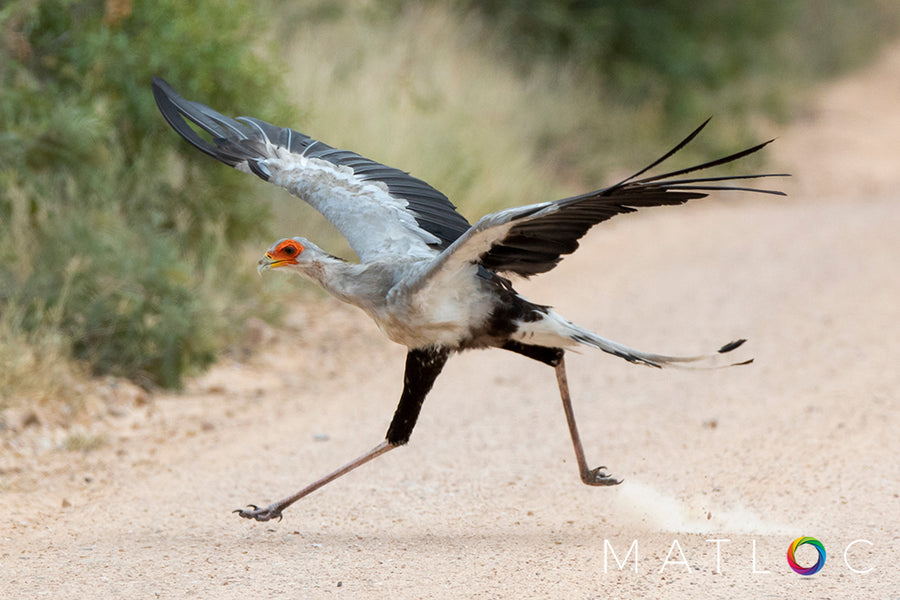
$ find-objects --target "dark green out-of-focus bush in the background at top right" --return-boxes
[460,0,900,113]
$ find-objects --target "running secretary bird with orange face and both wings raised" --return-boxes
[153,78,785,521]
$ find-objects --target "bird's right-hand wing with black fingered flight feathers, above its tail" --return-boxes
[412,119,787,289]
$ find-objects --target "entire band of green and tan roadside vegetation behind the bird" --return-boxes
[0,0,900,408]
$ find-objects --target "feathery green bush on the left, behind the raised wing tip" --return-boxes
[0,0,284,387]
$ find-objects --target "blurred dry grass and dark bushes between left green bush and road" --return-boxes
[277,0,900,220]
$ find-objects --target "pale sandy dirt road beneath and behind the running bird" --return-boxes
[0,47,900,599]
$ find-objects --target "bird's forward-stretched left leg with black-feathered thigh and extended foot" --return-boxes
[234,347,450,521]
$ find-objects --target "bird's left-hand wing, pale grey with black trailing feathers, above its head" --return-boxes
[153,77,469,261]
